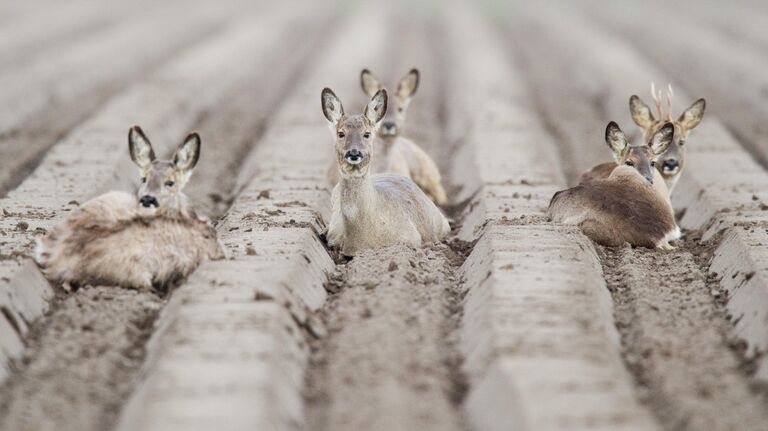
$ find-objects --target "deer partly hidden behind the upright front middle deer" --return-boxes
[328,69,448,205]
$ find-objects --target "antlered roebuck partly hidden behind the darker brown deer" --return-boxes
[581,83,707,194]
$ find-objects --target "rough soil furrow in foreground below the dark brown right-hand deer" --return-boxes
[601,241,768,430]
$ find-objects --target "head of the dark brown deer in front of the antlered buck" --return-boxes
[605,121,675,184]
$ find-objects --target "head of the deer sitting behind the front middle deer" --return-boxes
[360,68,420,138]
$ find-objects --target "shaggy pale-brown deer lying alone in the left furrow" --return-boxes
[35,127,224,289]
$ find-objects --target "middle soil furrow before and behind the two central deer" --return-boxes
[305,17,466,431]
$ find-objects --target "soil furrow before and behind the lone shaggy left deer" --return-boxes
[0,10,324,431]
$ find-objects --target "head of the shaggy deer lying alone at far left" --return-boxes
[128,126,201,214]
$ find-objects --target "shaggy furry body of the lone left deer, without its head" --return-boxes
[35,191,224,289]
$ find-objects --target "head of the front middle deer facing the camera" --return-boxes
[321,88,387,178]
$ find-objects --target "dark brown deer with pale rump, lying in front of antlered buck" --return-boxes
[548,122,680,250]
